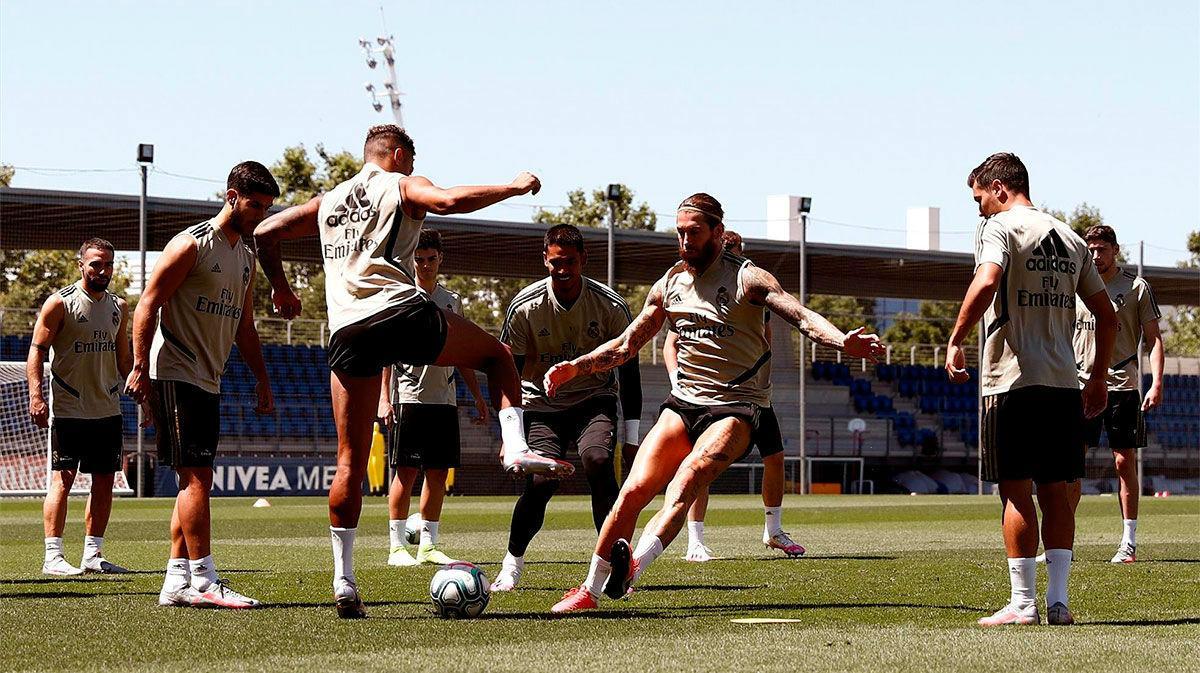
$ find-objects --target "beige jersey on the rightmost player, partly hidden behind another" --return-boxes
[1075,269,1163,390]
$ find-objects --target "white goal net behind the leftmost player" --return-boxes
[0,362,133,495]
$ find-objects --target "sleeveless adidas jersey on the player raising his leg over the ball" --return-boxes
[317,162,424,332]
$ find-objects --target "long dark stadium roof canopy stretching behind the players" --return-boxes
[0,188,1200,306]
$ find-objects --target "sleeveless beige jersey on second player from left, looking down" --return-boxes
[150,222,254,393]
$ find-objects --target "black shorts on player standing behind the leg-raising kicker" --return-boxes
[388,403,461,469]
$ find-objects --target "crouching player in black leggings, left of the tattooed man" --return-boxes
[492,224,642,591]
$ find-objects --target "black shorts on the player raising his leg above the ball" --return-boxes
[329,300,446,377]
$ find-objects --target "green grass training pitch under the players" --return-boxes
[0,495,1200,673]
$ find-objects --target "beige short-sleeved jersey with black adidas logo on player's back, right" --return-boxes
[976,205,1104,395]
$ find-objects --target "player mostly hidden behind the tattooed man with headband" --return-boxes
[662,229,804,563]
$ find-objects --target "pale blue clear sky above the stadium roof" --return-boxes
[0,0,1200,264]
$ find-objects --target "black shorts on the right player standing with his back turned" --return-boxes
[979,385,1085,483]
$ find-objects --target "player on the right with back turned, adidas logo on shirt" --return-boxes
[946,152,1116,626]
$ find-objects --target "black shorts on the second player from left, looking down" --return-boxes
[150,380,221,468]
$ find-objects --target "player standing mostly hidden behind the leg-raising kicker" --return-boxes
[379,229,488,566]
